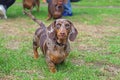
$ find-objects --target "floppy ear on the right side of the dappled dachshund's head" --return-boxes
[68,21,78,41]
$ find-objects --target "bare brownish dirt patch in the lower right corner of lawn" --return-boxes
[71,59,120,80]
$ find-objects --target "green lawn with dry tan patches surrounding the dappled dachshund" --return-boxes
[0,0,120,80]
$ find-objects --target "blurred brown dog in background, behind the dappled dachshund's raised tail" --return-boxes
[23,0,40,11]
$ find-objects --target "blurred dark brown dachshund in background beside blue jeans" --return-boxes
[47,0,67,20]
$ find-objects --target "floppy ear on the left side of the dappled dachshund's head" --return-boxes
[47,21,56,39]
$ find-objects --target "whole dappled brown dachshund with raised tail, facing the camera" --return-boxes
[25,12,78,73]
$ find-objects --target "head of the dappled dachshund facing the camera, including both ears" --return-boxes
[48,19,78,43]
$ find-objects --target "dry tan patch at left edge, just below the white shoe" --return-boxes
[0,18,37,36]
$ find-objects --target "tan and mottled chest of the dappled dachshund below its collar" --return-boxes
[47,41,67,63]
